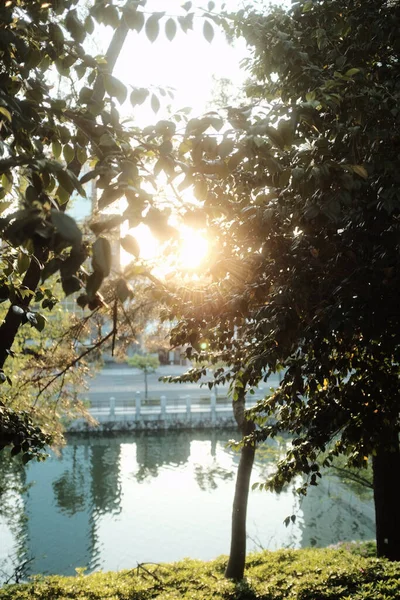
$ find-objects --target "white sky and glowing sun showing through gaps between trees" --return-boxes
[90,0,285,273]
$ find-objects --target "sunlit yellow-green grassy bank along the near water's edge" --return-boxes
[0,545,400,600]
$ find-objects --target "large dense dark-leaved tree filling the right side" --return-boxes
[162,0,400,579]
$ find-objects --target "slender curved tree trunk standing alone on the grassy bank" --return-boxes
[225,390,255,581]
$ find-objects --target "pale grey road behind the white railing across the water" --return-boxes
[86,365,279,406]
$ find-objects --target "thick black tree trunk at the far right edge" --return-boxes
[372,431,400,560]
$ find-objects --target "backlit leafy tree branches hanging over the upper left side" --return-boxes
[0,0,222,450]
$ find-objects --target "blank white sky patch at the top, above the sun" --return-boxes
[114,0,246,121]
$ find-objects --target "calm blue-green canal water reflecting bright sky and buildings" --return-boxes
[0,431,374,579]
